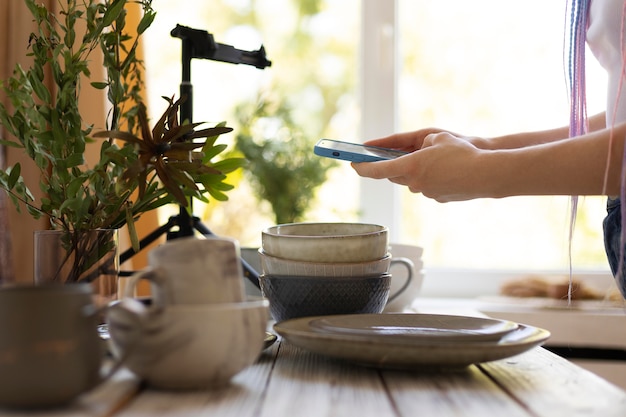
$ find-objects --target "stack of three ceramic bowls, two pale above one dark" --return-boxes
[259,223,391,321]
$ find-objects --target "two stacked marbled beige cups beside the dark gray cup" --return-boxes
[108,237,269,389]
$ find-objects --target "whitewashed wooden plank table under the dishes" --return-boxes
[0,320,626,417]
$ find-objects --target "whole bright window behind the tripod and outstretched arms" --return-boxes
[146,0,608,282]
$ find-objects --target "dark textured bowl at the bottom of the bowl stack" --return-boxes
[259,274,391,322]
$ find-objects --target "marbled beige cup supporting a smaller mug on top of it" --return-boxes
[108,300,269,390]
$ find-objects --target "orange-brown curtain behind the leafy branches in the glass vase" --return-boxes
[0,0,158,283]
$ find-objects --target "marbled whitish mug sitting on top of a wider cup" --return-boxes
[125,237,245,305]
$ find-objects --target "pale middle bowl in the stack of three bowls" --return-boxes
[259,249,391,277]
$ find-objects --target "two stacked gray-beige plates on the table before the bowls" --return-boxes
[274,314,550,369]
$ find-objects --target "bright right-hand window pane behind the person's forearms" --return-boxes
[398,0,607,270]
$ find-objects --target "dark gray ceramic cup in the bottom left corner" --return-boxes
[0,284,144,409]
